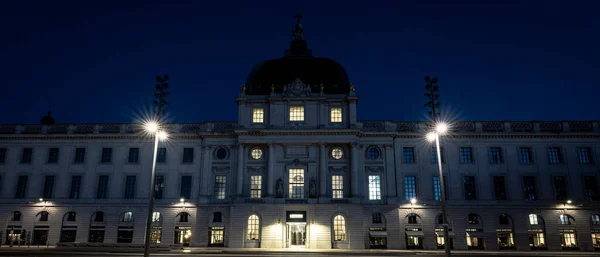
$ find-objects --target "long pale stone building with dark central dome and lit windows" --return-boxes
[0,20,600,251]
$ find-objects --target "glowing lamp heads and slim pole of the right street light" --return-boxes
[427,123,450,256]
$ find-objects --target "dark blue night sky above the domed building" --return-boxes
[0,0,600,124]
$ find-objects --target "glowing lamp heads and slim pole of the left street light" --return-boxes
[144,121,168,257]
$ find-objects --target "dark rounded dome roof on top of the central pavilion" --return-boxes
[246,40,350,95]
